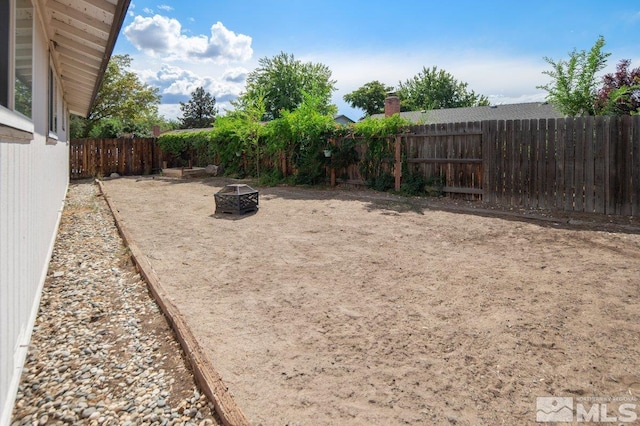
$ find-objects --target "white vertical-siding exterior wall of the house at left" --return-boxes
[0,2,69,426]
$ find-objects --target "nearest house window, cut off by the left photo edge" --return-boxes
[0,0,33,118]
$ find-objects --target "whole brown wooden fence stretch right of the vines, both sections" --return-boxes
[395,116,640,216]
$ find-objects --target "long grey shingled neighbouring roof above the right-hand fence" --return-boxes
[371,102,564,124]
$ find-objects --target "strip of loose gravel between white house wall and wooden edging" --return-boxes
[12,181,220,426]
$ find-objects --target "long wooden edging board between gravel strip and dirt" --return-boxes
[96,180,249,426]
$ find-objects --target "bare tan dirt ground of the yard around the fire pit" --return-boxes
[100,178,640,425]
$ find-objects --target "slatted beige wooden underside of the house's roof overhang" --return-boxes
[43,0,130,116]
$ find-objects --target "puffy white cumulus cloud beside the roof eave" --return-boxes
[124,15,253,63]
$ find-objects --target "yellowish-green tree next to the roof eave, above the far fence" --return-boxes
[71,55,161,138]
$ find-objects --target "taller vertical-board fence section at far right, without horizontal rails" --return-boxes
[483,116,640,216]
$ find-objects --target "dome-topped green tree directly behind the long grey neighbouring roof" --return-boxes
[397,66,489,111]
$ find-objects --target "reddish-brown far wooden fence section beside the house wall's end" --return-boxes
[69,138,162,179]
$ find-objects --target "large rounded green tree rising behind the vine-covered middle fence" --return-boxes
[240,52,336,121]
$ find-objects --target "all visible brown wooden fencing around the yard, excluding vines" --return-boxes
[71,116,640,216]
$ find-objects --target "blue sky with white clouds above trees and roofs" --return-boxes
[114,0,640,120]
